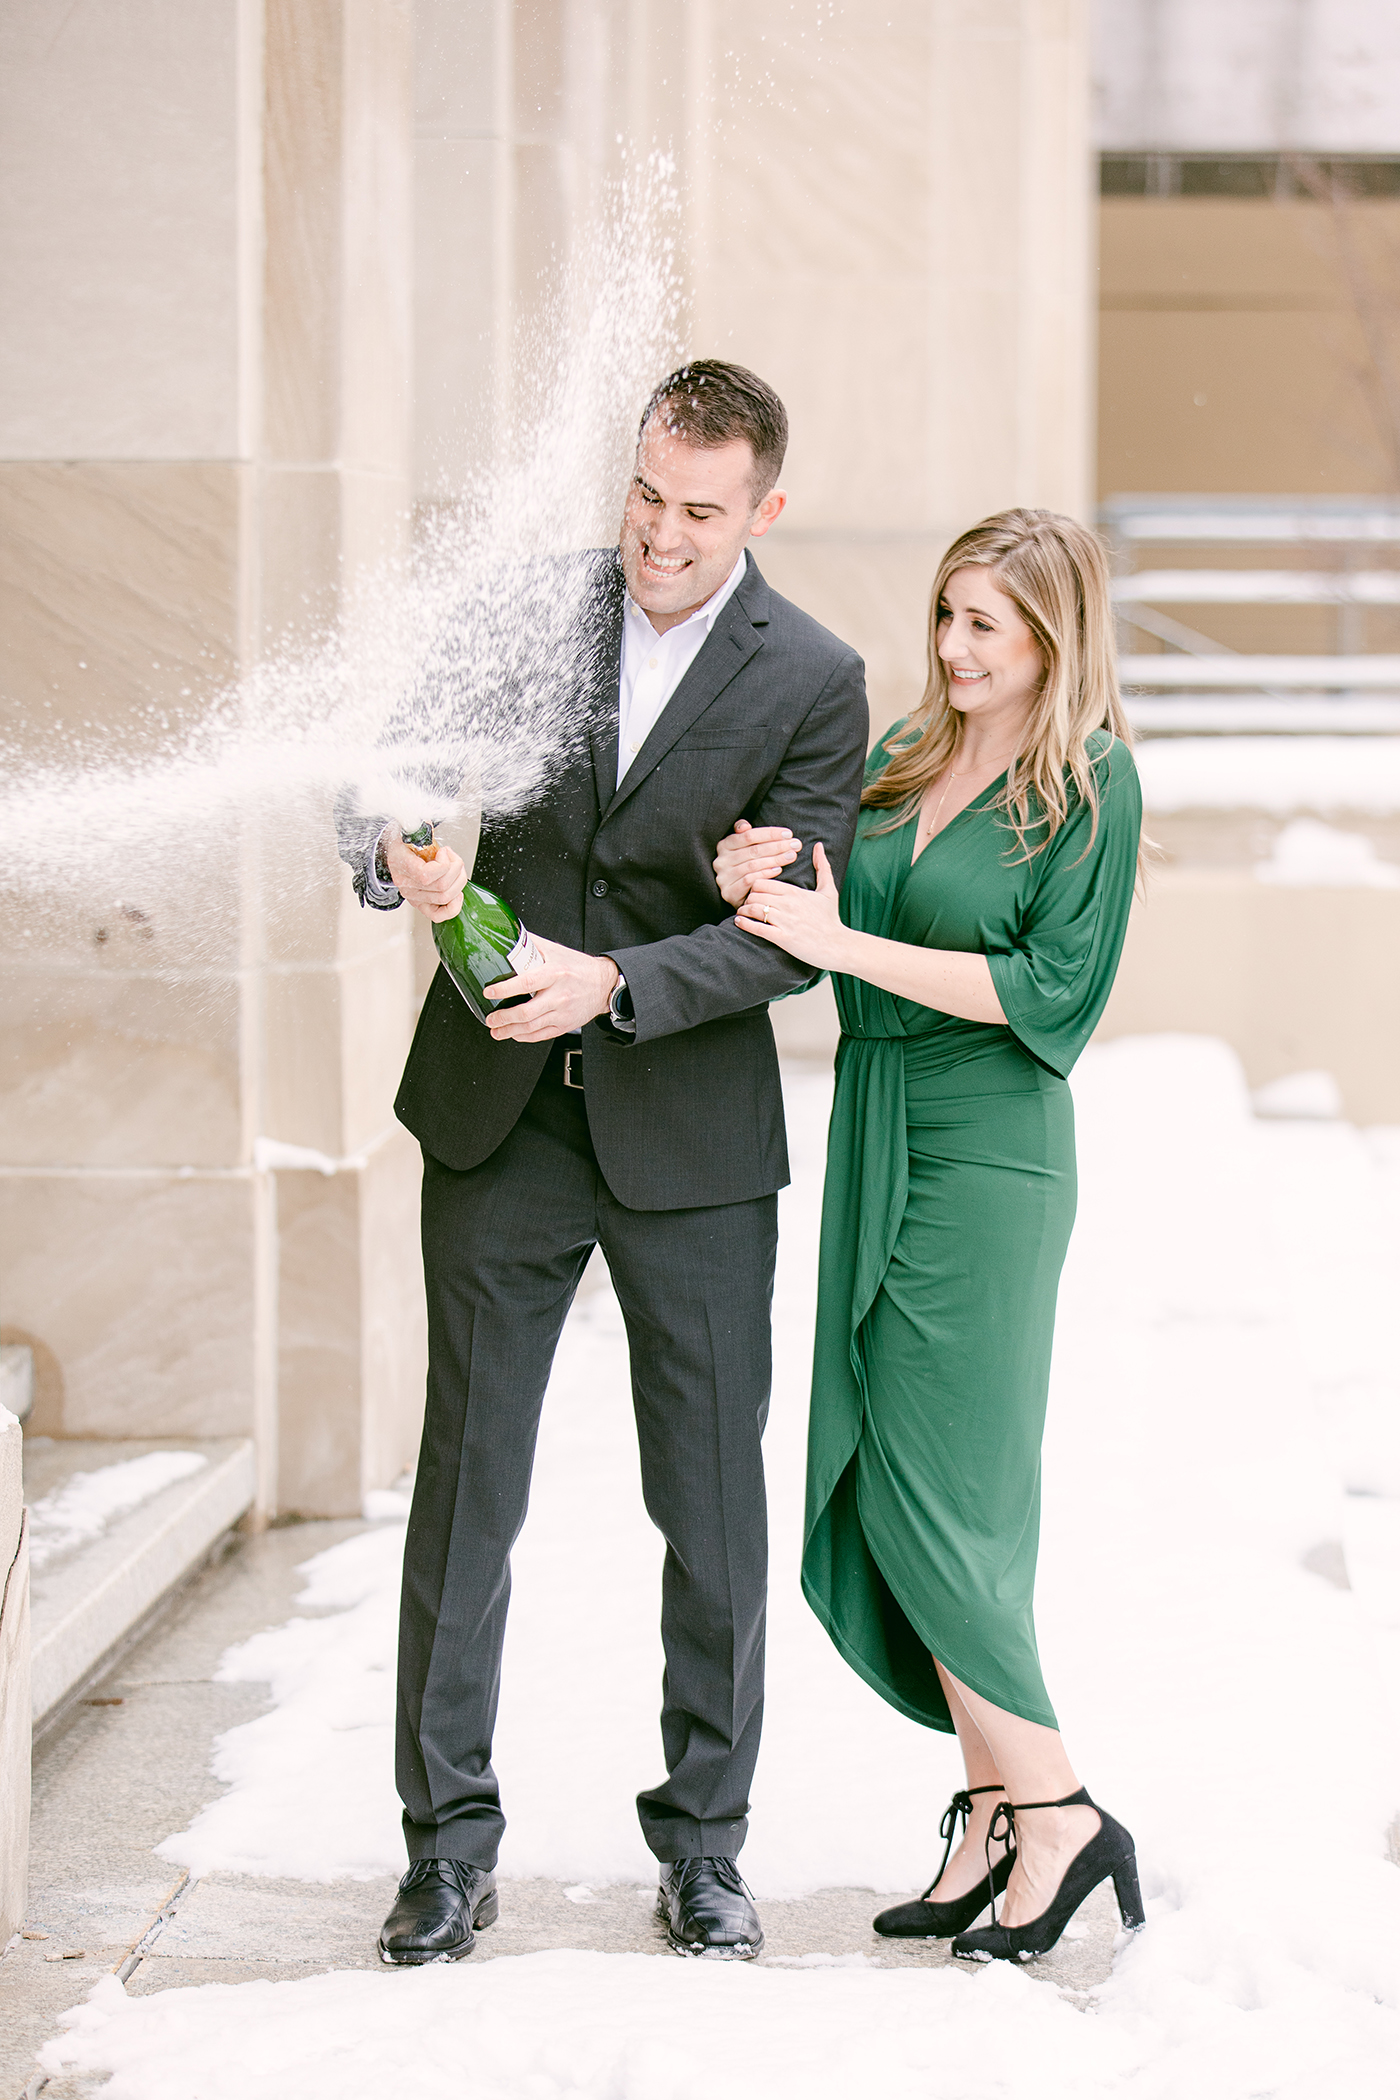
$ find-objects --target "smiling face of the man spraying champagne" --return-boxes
[619,416,787,634]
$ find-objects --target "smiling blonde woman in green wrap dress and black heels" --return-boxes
[716,510,1142,1959]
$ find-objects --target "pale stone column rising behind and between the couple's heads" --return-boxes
[680,0,1096,725]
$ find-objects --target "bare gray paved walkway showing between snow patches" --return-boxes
[0,1523,1117,2100]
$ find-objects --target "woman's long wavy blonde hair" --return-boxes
[861,510,1131,861]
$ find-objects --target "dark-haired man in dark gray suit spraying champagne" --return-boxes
[342,361,867,1964]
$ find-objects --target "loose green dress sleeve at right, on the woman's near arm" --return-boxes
[987,741,1142,1079]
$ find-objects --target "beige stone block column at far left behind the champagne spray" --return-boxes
[0,0,422,1516]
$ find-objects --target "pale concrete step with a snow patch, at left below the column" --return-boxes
[25,1436,254,1735]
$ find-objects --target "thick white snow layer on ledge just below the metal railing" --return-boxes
[1133,737,1400,817]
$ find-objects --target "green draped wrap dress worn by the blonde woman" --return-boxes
[802,725,1142,1730]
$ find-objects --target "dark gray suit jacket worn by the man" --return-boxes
[340,552,867,1210]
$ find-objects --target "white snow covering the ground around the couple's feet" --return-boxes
[46,1037,1400,2100]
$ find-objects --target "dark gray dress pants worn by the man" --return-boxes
[397,1044,777,1867]
